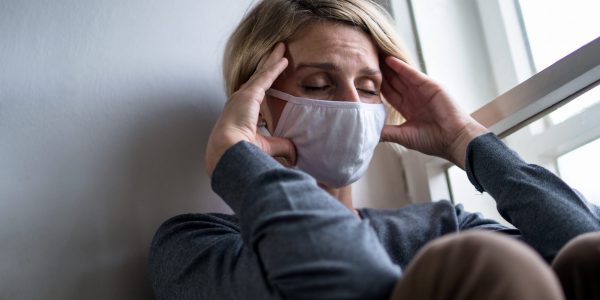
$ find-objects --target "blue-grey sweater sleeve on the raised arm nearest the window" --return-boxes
[465,133,600,260]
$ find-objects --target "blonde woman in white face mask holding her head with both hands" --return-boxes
[150,0,600,299]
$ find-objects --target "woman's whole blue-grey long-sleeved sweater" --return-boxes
[149,134,600,299]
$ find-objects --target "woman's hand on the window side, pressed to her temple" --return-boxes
[381,56,488,169]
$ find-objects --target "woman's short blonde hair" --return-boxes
[223,0,408,124]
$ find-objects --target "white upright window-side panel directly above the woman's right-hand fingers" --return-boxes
[412,0,498,112]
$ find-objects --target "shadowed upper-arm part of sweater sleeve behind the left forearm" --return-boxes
[148,214,283,300]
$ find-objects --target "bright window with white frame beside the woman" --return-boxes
[390,0,600,220]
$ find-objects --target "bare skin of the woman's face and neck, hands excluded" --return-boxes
[261,22,383,211]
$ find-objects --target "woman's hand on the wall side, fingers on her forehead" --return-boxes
[205,43,296,177]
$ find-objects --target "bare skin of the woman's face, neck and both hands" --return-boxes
[206,22,488,215]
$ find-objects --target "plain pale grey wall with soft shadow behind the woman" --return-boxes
[0,0,402,299]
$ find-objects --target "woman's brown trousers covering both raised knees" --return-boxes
[390,231,600,300]
